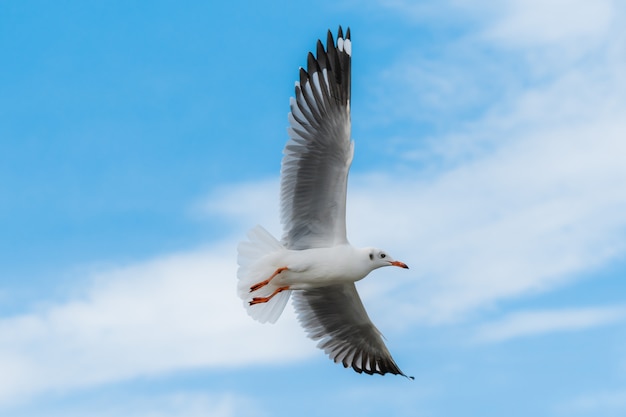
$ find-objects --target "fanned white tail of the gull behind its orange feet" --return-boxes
[237,225,291,323]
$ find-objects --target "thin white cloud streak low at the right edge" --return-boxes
[474,307,626,342]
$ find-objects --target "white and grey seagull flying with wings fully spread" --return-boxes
[237,26,408,377]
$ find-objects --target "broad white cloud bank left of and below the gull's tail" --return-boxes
[0,243,314,404]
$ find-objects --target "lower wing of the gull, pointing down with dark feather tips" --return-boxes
[294,283,406,377]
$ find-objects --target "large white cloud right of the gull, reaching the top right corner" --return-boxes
[348,1,626,325]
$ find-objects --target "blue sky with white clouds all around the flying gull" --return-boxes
[0,0,626,417]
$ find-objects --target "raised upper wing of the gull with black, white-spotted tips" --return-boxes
[281,27,354,249]
